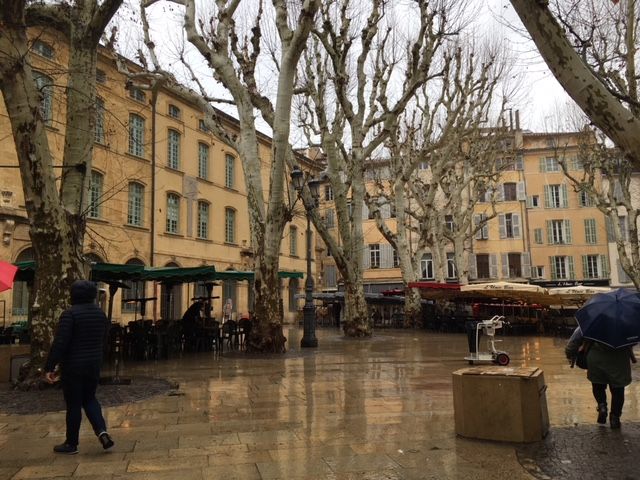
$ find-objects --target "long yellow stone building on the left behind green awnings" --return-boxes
[0,34,312,324]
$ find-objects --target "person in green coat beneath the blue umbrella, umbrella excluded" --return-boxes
[565,327,636,429]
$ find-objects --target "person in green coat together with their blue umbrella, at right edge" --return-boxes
[565,288,640,429]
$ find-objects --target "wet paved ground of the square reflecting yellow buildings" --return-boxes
[0,329,640,480]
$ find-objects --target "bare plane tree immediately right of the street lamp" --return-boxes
[300,0,482,337]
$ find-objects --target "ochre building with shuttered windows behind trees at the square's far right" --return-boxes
[322,130,611,293]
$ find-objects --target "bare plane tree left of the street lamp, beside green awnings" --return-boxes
[142,0,320,352]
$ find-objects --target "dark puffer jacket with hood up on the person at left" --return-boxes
[45,280,109,372]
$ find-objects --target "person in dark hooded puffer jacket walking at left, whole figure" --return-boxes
[45,280,114,455]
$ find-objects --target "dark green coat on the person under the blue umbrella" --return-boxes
[587,342,631,387]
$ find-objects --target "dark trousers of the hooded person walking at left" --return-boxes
[62,366,107,446]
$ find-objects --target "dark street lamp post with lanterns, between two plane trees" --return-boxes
[291,166,320,347]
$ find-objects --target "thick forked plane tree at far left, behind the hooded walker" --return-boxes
[0,0,122,388]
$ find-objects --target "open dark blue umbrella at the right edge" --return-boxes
[576,288,640,348]
